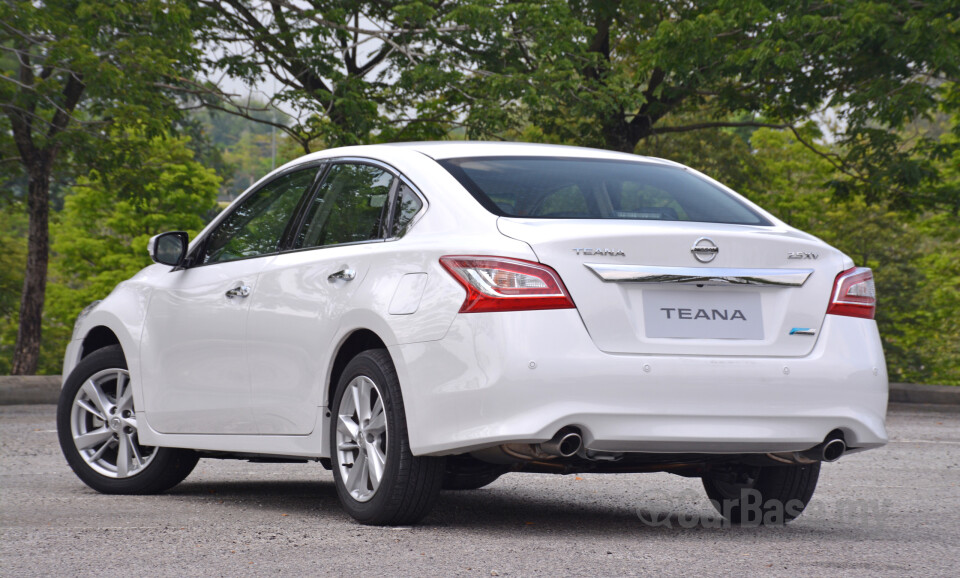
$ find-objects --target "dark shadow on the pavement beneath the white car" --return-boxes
[168,480,869,539]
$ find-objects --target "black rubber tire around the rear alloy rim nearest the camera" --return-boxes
[330,349,445,526]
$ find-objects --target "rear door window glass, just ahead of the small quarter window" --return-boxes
[294,164,394,249]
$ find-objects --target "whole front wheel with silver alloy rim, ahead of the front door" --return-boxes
[57,345,199,494]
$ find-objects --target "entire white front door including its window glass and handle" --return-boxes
[140,165,319,434]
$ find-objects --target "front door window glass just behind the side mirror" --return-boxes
[199,167,318,263]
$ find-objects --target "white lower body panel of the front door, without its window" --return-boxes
[140,259,264,434]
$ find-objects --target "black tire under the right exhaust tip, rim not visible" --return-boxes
[703,462,820,526]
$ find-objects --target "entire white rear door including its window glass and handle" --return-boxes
[247,163,396,435]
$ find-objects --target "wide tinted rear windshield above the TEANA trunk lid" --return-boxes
[438,157,771,225]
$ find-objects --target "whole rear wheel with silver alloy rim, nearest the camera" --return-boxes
[329,349,444,526]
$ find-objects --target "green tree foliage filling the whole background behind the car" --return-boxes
[0,0,960,383]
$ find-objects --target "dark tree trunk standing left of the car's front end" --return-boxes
[11,162,53,375]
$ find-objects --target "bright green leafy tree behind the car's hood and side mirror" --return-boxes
[41,133,220,373]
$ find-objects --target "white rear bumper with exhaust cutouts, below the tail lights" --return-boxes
[390,309,887,455]
